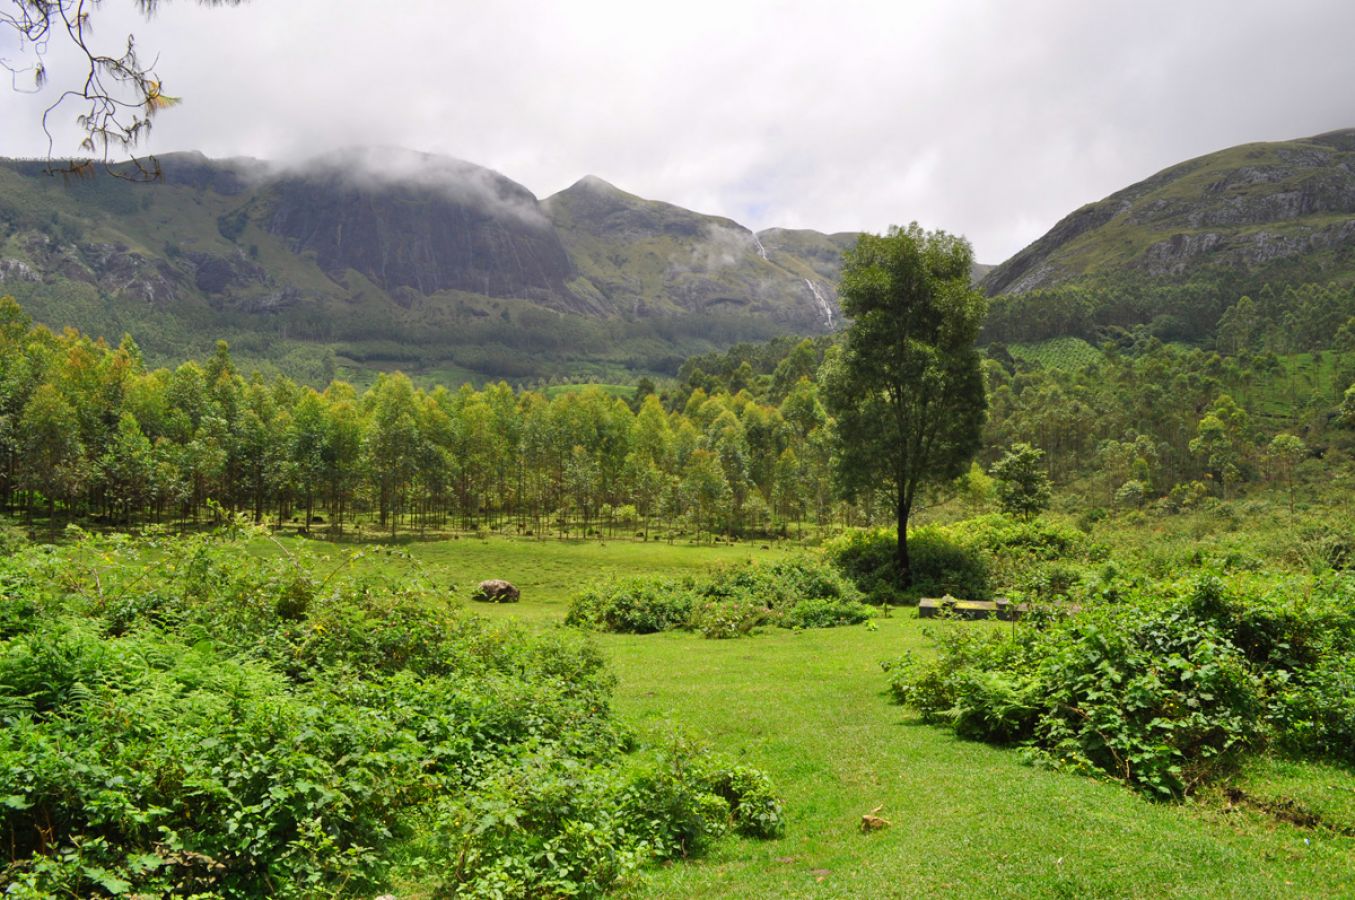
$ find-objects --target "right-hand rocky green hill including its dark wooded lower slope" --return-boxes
[981,130,1355,354]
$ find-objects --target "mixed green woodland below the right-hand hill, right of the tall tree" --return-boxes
[985,338,1338,511]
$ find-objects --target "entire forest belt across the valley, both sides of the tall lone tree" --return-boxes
[0,289,1355,538]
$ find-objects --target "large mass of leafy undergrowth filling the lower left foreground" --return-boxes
[0,523,782,897]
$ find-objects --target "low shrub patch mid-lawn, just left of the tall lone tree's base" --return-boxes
[565,557,871,638]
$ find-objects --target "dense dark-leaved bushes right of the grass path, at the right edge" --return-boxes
[886,567,1355,797]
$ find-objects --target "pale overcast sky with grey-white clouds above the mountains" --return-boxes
[0,0,1355,263]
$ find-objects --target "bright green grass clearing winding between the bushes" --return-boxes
[299,538,1355,897]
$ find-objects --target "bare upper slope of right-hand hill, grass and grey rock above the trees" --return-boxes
[982,130,1355,295]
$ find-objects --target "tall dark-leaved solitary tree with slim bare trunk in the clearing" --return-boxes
[824,222,988,587]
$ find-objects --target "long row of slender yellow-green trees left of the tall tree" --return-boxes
[0,298,845,535]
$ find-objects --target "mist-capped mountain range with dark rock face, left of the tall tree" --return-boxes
[0,149,855,380]
